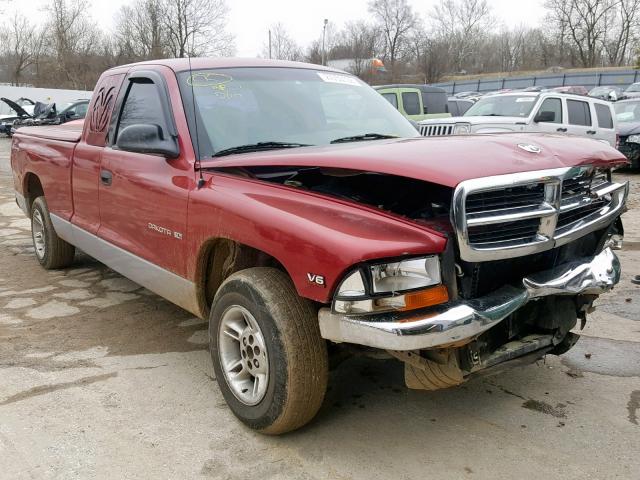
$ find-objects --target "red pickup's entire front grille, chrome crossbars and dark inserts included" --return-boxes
[453,167,629,262]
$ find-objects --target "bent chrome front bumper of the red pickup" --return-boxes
[318,248,620,350]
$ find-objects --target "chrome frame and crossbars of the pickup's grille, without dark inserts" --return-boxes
[451,167,629,262]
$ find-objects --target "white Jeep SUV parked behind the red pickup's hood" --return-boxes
[418,92,616,147]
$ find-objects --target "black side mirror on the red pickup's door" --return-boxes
[116,123,180,158]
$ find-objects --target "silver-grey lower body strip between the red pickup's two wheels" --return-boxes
[50,214,202,316]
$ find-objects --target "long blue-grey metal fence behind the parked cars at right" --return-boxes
[432,69,640,95]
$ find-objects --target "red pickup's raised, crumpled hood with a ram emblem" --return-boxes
[202,133,627,187]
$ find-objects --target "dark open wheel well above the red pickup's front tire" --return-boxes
[196,238,287,318]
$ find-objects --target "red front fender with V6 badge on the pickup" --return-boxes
[188,174,446,303]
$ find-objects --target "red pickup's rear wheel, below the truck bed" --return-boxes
[31,197,76,270]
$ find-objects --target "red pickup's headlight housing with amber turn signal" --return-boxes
[333,256,449,315]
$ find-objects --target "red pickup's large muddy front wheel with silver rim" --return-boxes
[209,268,328,435]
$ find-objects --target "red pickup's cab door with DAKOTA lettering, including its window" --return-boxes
[98,67,195,275]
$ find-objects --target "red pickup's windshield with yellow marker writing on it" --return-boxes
[178,67,419,157]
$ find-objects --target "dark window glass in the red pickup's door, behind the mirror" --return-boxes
[116,78,167,139]
